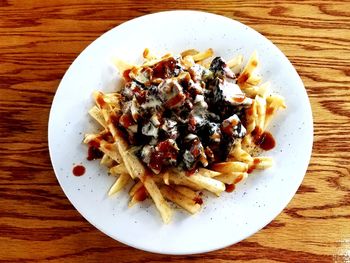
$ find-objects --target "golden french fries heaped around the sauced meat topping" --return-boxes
[84,49,285,223]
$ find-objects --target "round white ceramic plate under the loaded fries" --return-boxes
[49,11,313,254]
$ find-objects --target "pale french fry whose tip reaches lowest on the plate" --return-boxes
[143,176,172,224]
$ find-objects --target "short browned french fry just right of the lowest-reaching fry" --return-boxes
[160,185,201,214]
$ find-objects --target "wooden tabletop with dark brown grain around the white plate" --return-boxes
[0,0,350,262]
